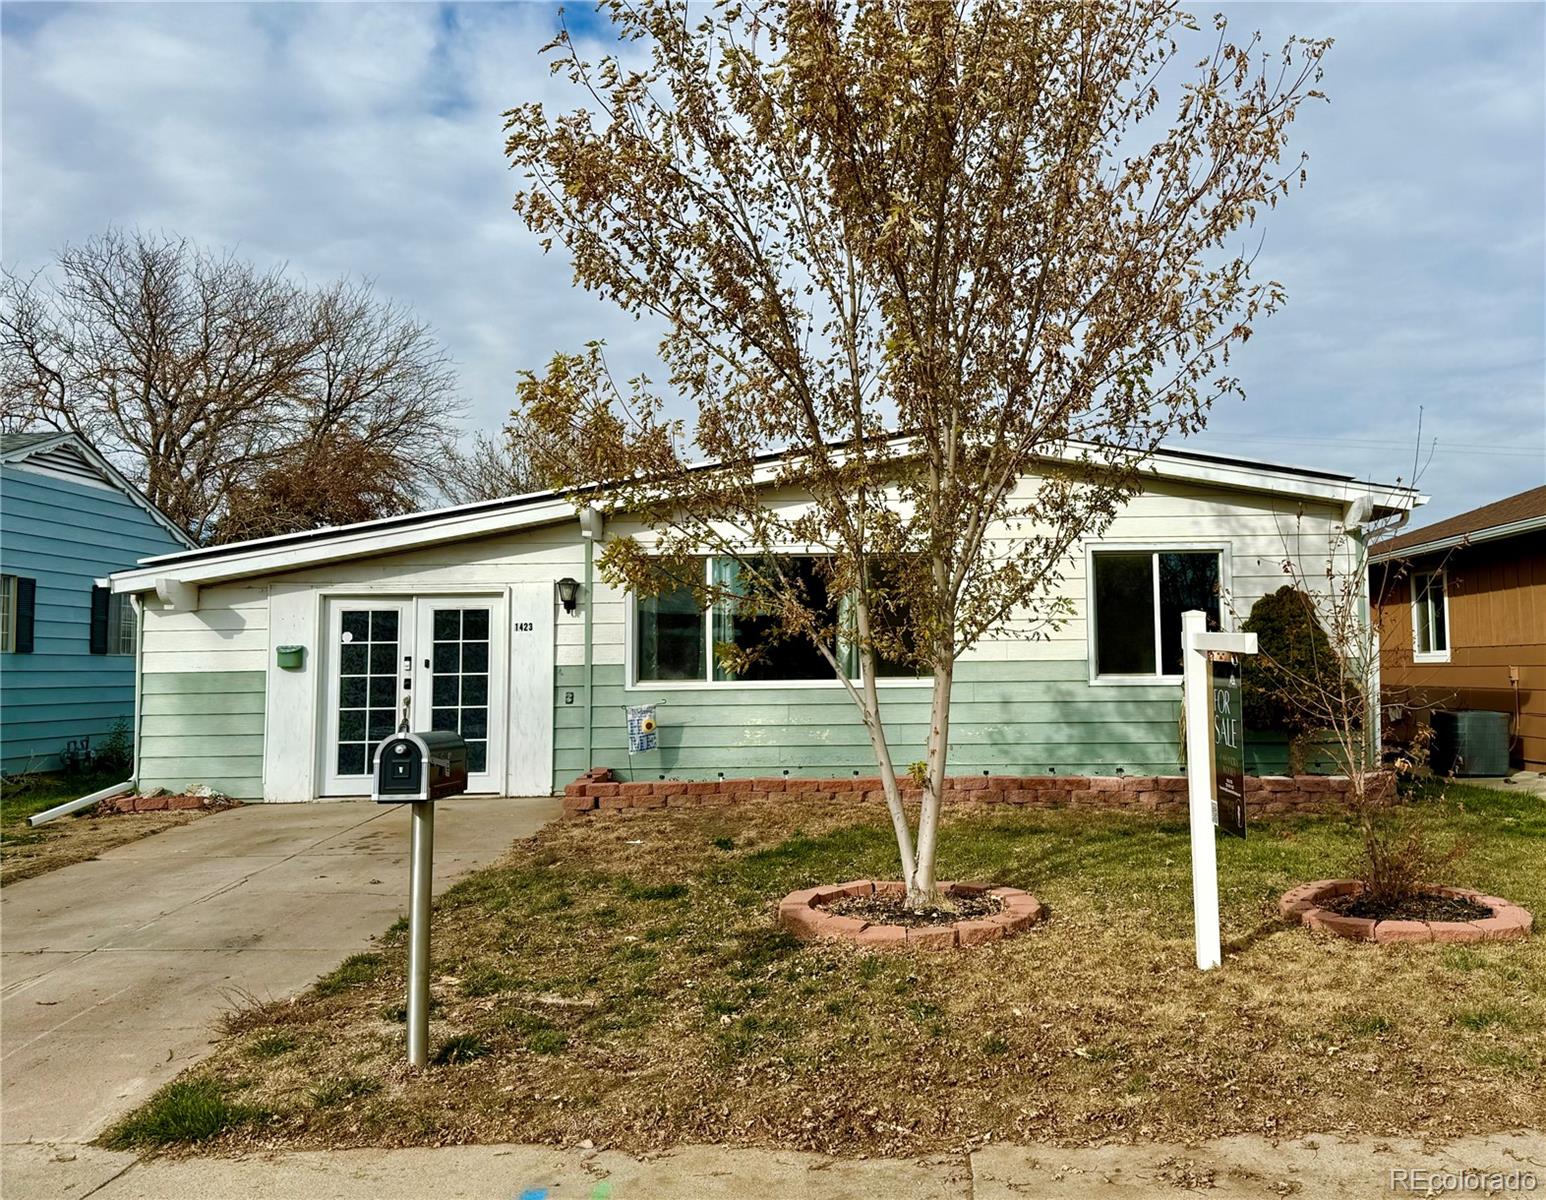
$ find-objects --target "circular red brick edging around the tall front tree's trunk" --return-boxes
[778,880,1047,949]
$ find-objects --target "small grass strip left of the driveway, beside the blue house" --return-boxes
[0,772,204,885]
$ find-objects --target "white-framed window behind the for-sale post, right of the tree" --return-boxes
[1090,549,1221,679]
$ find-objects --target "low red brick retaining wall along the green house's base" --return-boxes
[564,769,1394,816]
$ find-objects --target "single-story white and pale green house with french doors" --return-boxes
[102,450,1422,801]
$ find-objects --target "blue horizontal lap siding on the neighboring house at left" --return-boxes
[0,467,182,772]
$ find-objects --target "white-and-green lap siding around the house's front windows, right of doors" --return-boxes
[553,484,1337,787]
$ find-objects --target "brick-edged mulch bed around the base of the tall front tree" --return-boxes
[778,880,1047,949]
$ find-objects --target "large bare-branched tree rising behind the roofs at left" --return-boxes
[0,229,459,540]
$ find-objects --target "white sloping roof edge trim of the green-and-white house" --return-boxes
[113,448,1425,592]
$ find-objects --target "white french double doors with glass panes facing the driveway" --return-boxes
[323,597,506,796]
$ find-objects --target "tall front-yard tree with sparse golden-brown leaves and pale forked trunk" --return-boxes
[507,0,1328,903]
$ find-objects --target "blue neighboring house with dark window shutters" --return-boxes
[0,431,193,775]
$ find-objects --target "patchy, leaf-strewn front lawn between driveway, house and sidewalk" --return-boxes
[117,787,1546,1154]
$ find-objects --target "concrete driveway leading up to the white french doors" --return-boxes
[0,798,560,1158]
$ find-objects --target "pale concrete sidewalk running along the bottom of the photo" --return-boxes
[5,1134,1546,1200]
